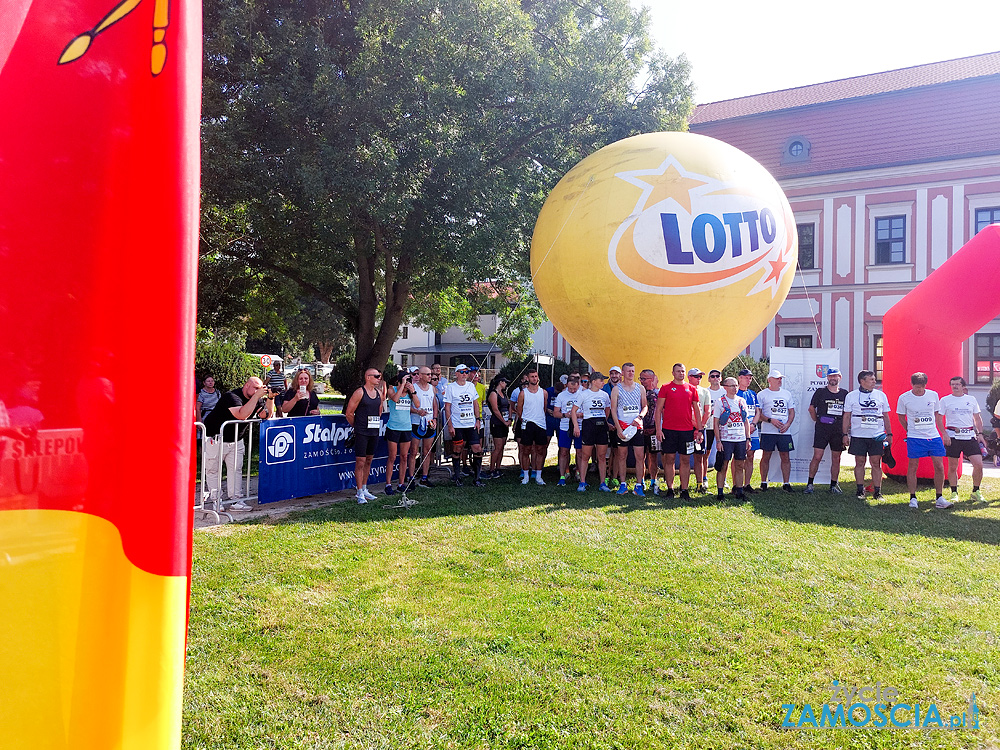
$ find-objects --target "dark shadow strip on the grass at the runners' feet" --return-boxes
[245,470,1000,545]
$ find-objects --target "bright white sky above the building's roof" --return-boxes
[648,0,1000,104]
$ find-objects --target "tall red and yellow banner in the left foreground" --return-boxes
[0,0,201,750]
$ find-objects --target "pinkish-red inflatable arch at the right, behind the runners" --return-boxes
[882,225,1000,477]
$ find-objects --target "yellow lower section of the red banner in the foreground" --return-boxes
[0,510,187,750]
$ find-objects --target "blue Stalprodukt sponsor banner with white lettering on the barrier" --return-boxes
[257,415,387,503]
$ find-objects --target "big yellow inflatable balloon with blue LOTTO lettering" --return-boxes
[531,133,798,382]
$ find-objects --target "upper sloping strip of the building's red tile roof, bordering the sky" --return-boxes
[689,52,1000,125]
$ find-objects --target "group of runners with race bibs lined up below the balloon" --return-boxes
[345,362,983,508]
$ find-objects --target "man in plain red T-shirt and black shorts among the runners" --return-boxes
[656,363,703,500]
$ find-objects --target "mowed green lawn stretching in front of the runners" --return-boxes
[184,470,1000,750]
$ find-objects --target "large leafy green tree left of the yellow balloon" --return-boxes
[202,0,691,382]
